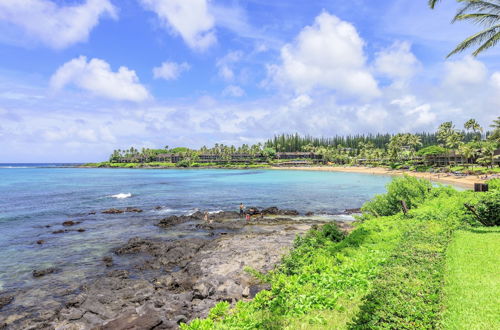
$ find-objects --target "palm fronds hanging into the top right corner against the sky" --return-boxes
[429,0,500,57]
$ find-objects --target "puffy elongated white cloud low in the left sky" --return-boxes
[50,56,150,102]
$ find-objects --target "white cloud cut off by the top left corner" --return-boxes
[0,0,117,49]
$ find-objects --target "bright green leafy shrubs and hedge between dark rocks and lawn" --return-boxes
[182,177,500,329]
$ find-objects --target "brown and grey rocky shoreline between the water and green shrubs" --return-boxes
[0,207,353,330]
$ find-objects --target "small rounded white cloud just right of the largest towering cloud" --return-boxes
[374,42,420,82]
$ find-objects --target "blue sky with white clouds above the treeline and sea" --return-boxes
[0,0,500,163]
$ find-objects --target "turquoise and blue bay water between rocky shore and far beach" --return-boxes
[0,166,390,291]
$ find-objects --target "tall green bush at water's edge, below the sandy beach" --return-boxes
[362,175,432,216]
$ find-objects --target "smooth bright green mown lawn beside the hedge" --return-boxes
[443,227,500,329]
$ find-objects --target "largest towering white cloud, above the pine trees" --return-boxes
[269,12,380,98]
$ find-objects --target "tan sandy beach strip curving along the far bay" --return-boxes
[271,166,486,189]
